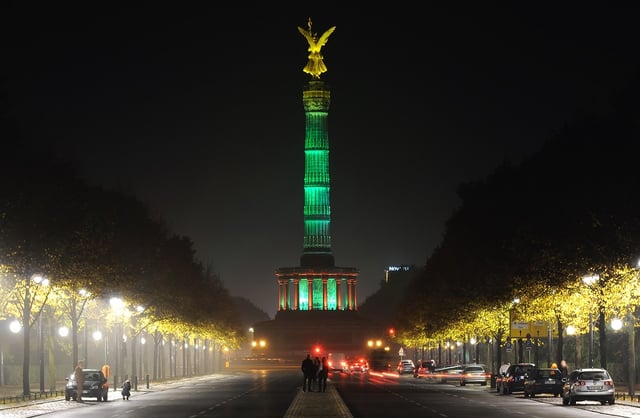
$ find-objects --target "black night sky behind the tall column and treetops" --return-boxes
[1,2,640,317]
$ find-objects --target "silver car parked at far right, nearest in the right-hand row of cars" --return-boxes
[562,368,616,405]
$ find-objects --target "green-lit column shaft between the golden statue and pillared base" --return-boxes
[300,80,334,267]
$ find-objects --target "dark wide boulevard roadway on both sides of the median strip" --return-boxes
[0,367,640,418]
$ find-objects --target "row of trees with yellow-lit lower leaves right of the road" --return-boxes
[397,83,640,390]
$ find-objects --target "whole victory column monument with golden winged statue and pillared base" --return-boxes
[276,19,359,312]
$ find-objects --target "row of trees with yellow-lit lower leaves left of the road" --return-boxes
[0,140,244,394]
